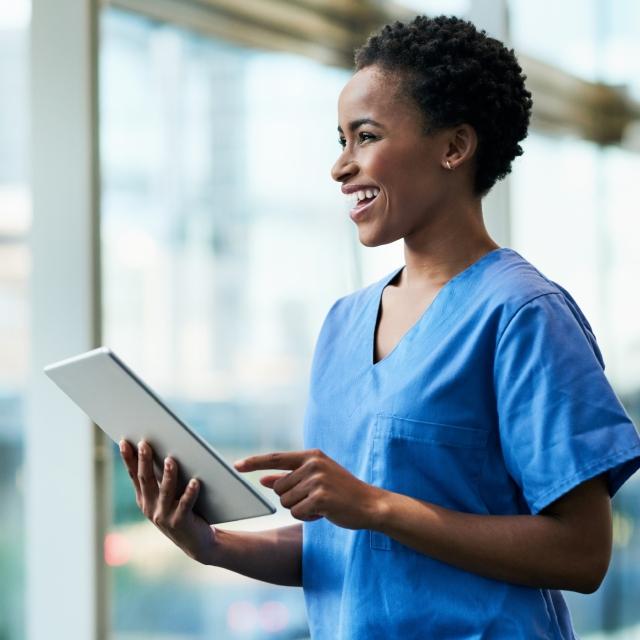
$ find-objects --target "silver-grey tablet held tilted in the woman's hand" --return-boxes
[44,347,276,524]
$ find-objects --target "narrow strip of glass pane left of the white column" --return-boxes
[0,0,31,640]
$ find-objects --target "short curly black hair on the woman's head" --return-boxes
[354,15,533,197]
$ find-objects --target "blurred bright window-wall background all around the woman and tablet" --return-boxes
[0,0,640,640]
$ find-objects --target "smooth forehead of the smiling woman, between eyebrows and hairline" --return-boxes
[338,65,419,128]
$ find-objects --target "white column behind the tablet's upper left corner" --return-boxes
[25,0,105,640]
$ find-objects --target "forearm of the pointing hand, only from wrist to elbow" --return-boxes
[375,491,598,593]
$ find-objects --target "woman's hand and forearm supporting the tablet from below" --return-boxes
[120,440,302,586]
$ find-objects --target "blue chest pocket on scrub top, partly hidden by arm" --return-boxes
[369,413,489,550]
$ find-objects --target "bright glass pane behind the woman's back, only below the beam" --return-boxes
[510,133,640,640]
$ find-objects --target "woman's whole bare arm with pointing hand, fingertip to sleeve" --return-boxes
[236,450,612,593]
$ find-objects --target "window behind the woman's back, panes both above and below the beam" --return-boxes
[509,0,640,640]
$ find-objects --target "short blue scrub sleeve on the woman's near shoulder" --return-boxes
[494,293,640,514]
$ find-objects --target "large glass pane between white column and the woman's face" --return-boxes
[101,10,352,639]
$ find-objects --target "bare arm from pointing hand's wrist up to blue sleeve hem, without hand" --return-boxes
[374,476,612,593]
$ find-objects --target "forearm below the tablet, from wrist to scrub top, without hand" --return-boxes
[208,524,302,587]
